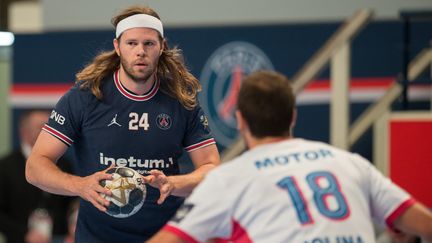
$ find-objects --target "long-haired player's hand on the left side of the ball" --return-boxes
[77,166,113,212]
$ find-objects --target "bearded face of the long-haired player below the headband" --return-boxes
[114,28,161,83]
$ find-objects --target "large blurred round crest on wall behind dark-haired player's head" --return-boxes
[200,41,274,147]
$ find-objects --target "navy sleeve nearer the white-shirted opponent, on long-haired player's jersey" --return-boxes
[183,105,216,152]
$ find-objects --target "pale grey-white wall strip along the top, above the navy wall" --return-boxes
[40,0,432,30]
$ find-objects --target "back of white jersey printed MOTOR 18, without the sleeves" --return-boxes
[212,139,408,242]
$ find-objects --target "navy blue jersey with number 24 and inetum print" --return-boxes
[43,71,215,242]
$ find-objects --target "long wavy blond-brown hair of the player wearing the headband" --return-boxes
[75,6,201,109]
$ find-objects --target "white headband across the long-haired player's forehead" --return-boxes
[116,14,163,38]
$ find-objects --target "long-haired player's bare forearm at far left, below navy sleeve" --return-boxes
[26,155,79,196]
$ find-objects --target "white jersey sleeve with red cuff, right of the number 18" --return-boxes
[355,155,415,228]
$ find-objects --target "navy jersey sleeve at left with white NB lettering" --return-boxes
[42,85,85,146]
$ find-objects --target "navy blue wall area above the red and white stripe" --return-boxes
[13,21,432,83]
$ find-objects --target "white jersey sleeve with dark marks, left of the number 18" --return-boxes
[164,172,232,242]
